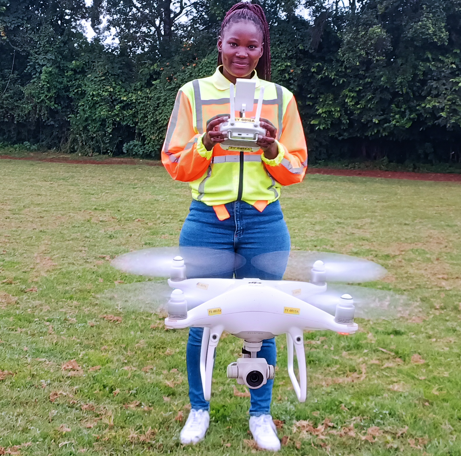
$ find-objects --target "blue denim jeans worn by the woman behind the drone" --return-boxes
[179,200,290,416]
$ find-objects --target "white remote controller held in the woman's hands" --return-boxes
[220,79,266,152]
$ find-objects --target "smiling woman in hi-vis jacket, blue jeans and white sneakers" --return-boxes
[162,3,307,451]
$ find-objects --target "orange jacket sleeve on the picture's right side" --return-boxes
[261,95,307,185]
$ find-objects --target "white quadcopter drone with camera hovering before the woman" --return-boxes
[113,248,385,402]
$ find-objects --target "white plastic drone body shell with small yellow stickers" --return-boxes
[165,279,357,336]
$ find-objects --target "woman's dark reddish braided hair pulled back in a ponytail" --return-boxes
[218,2,271,81]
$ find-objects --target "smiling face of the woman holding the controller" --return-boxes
[218,21,263,84]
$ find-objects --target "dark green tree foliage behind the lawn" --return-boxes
[0,0,461,163]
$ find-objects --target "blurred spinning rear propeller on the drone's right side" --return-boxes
[251,250,386,283]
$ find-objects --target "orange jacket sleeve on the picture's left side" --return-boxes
[162,89,213,182]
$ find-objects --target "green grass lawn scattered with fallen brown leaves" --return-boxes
[0,160,461,456]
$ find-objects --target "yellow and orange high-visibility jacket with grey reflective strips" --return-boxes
[162,68,307,220]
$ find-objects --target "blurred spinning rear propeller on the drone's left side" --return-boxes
[112,247,245,278]
